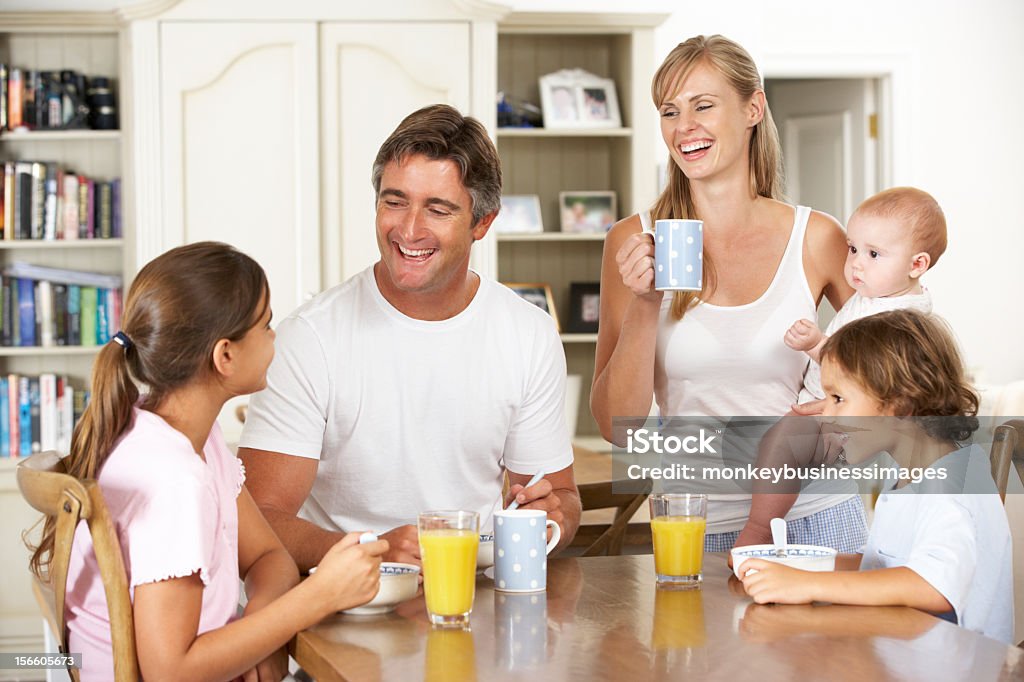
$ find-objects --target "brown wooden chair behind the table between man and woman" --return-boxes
[569,479,651,556]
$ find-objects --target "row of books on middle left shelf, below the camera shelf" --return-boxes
[0,161,122,241]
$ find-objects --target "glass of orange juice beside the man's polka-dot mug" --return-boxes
[418,511,480,628]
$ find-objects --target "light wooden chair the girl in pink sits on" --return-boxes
[17,452,139,682]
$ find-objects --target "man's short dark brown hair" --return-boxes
[372,104,502,225]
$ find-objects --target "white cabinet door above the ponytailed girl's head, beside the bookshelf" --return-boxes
[160,22,321,319]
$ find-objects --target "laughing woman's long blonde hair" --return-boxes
[650,35,782,319]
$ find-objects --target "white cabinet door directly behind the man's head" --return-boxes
[321,23,470,287]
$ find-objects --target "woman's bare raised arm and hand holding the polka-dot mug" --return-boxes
[590,215,663,444]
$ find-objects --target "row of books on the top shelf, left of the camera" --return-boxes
[0,63,99,130]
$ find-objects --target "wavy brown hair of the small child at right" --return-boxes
[821,310,979,440]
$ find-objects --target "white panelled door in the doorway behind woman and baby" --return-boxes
[766,78,879,225]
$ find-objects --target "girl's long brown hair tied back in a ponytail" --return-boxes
[30,242,269,577]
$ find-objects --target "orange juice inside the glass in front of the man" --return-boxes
[420,528,480,615]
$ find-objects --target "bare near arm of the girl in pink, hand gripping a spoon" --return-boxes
[133,534,387,682]
